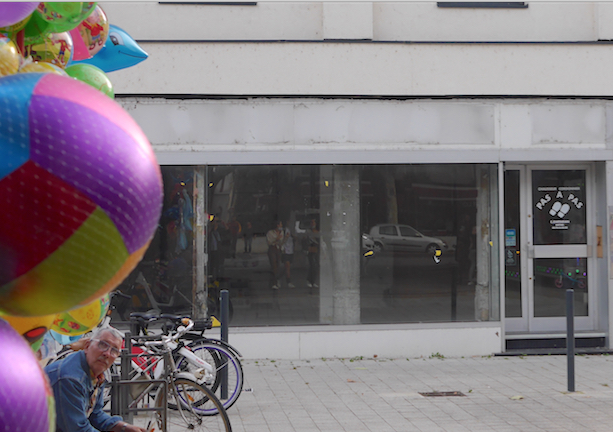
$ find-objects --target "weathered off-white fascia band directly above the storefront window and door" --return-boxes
[118,98,613,164]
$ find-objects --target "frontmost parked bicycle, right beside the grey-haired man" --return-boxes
[120,319,232,432]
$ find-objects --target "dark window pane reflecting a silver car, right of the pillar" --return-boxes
[360,164,499,323]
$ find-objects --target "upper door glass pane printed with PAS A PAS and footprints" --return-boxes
[532,170,587,245]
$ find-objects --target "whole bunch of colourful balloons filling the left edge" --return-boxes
[0,2,162,432]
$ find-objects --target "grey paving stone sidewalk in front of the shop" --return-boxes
[228,355,613,432]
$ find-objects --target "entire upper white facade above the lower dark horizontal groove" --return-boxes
[101,2,613,96]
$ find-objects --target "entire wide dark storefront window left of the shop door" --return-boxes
[113,164,499,326]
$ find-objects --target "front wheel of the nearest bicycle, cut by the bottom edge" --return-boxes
[156,378,232,432]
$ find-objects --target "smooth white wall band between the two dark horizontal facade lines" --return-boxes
[109,42,613,96]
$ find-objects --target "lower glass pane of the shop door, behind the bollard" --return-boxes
[534,258,588,317]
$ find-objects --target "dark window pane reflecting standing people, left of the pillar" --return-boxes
[207,165,325,326]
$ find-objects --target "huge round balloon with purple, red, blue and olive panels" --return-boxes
[0,73,162,316]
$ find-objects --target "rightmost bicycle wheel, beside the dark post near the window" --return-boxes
[173,339,243,415]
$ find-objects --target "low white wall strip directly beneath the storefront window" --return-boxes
[210,323,503,359]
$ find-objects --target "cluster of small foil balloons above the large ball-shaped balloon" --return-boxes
[0,2,148,94]
